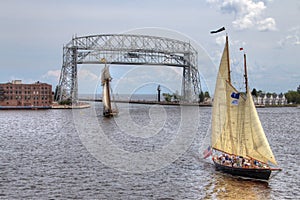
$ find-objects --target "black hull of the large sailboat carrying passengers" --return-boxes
[214,161,271,180]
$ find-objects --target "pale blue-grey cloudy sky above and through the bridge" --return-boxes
[0,0,300,93]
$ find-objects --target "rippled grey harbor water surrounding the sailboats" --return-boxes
[0,103,300,199]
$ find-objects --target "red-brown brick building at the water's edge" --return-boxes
[0,80,53,108]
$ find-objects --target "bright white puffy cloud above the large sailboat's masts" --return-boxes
[207,0,276,31]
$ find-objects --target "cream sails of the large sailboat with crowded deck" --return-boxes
[211,36,277,164]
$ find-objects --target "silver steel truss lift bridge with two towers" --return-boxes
[55,34,200,102]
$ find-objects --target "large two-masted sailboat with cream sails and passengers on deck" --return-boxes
[205,35,281,180]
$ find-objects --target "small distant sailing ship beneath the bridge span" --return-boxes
[101,64,118,117]
